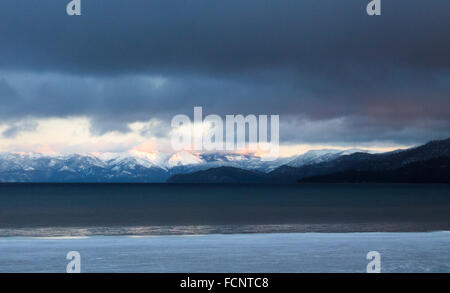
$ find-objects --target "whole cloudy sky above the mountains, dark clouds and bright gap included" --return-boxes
[0,0,450,152]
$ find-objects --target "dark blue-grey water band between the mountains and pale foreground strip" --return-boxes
[0,184,450,236]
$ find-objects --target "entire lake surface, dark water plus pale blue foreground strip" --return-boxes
[0,184,450,272]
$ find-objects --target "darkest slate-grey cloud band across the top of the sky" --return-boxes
[0,0,450,73]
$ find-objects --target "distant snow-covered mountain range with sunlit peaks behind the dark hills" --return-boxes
[0,149,366,182]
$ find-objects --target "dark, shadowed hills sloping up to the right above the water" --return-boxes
[167,138,450,184]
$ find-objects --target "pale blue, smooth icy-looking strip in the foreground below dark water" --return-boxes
[0,232,450,273]
